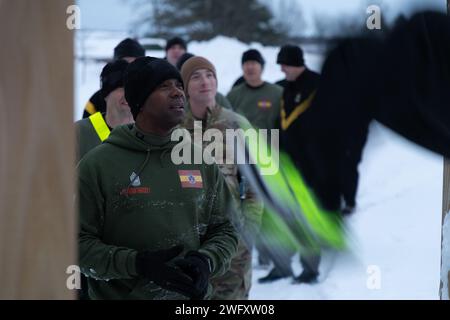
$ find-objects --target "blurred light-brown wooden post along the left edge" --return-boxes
[0,0,76,299]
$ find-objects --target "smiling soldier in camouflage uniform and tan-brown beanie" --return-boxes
[181,57,263,300]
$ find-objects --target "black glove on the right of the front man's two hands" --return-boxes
[175,251,211,300]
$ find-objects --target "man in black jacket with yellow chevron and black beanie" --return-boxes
[259,44,320,283]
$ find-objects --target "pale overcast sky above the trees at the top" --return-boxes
[76,0,446,31]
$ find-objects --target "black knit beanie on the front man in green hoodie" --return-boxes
[124,57,183,120]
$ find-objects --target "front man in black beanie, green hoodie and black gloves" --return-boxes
[77,57,237,300]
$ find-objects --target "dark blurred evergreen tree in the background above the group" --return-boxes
[137,0,287,45]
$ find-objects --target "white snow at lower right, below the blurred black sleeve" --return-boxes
[250,123,442,299]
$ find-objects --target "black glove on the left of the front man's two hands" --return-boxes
[136,245,195,297]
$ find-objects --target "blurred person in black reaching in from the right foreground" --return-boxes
[309,12,450,215]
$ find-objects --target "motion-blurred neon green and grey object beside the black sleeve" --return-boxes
[240,124,346,254]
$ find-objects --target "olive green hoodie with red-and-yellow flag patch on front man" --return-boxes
[78,125,237,299]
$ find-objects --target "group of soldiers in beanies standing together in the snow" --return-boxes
[75,37,356,299]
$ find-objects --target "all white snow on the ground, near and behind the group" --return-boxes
[74,35,443,299]
